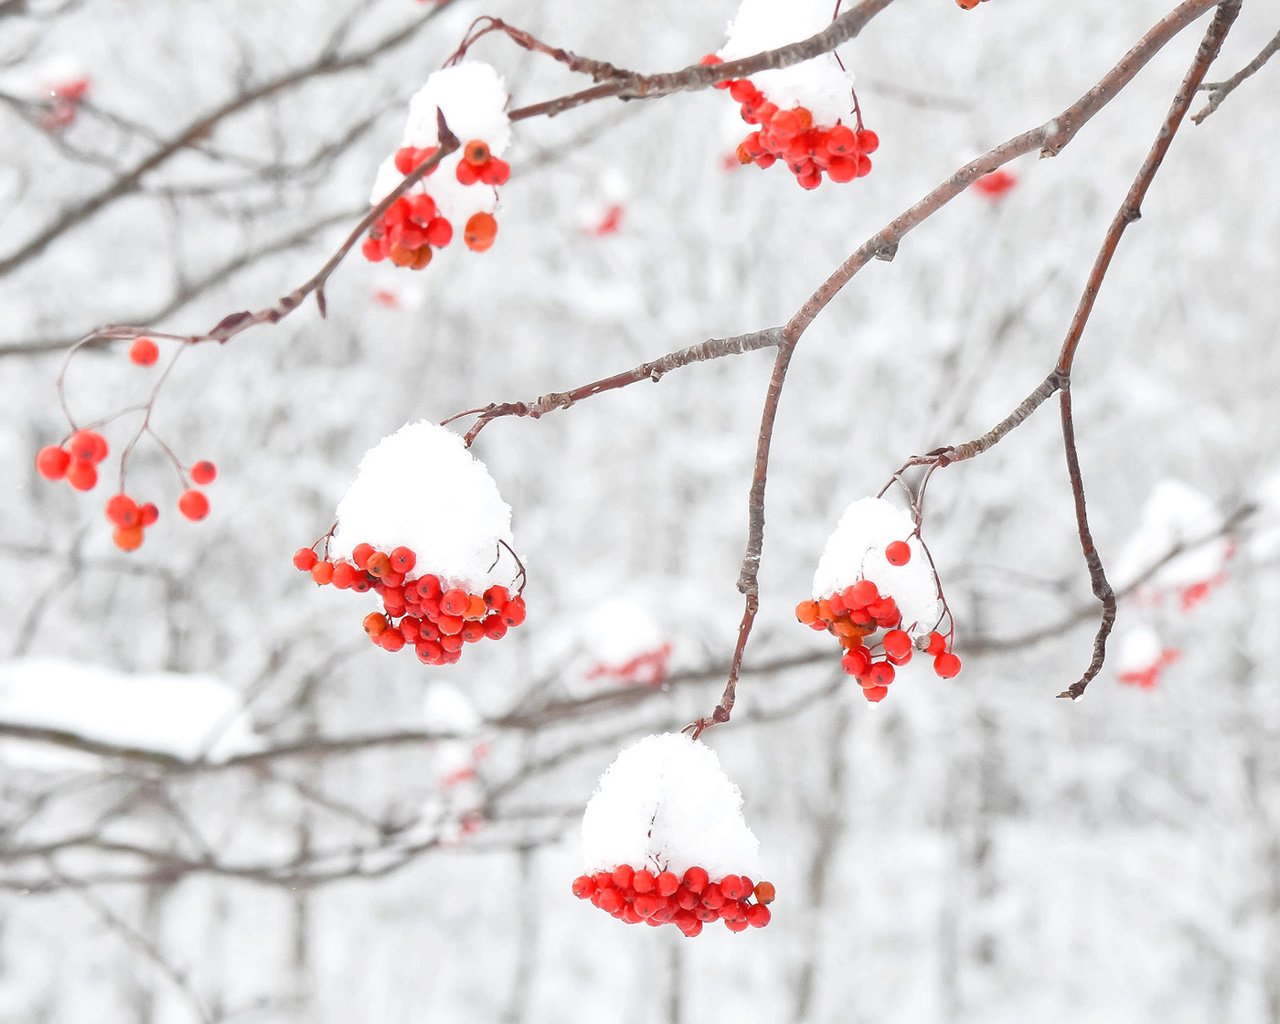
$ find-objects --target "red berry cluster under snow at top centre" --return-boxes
[701,54,879,188]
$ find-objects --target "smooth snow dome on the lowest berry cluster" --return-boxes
[582,732,760,881]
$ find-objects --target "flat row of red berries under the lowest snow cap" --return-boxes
[573,864,776,938]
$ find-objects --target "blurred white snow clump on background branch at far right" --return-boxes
[1114,480,1231,589]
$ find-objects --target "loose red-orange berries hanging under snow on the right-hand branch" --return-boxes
[796,540,960,703]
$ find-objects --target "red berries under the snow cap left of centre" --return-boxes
[293,544,525,664]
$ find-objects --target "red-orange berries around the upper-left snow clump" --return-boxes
[361,140,511,270]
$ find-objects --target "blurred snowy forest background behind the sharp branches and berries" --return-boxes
[0,0,1280,1024]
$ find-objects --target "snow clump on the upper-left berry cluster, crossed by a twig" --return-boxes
[369,60,511,225]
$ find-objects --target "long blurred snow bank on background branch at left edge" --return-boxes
[0,658,261,768]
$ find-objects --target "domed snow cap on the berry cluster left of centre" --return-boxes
[330,420,516,594]
